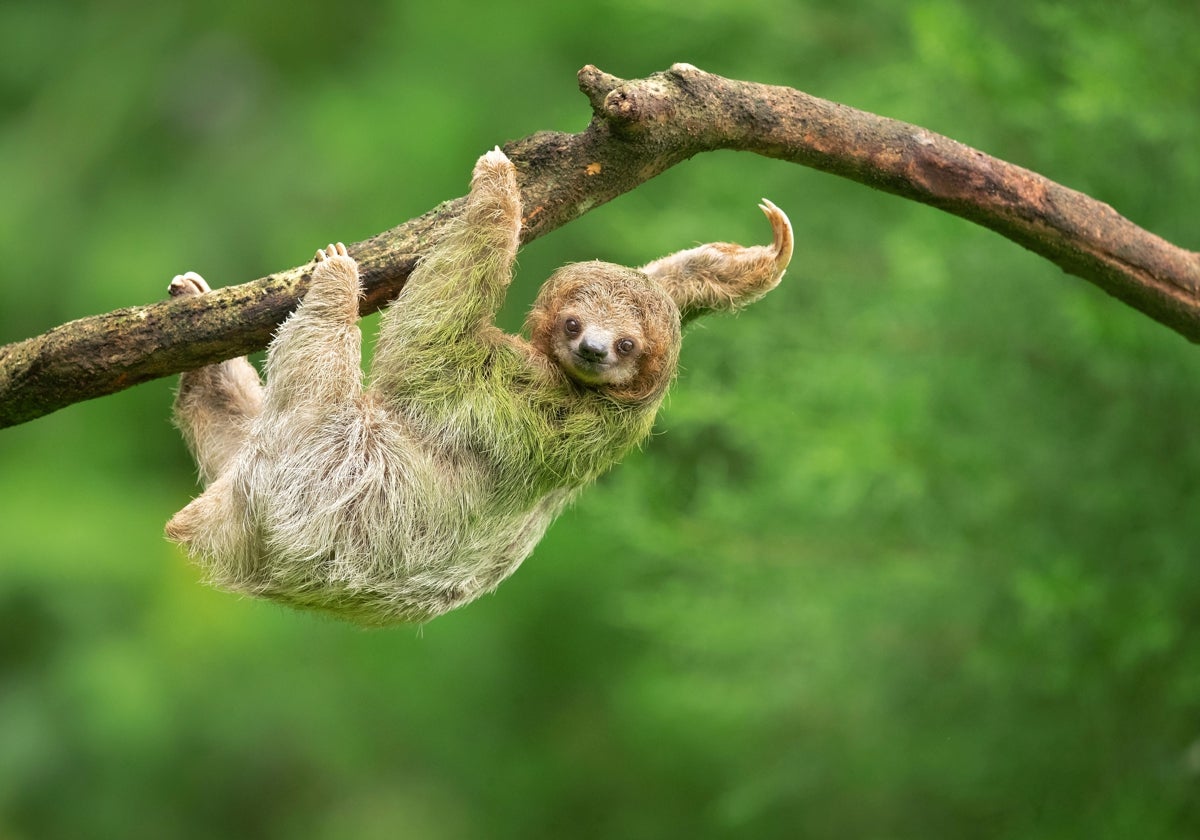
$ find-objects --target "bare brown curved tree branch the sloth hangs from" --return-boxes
[0,65,1200,426]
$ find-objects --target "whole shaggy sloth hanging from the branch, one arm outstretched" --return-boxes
[166,149,792,626]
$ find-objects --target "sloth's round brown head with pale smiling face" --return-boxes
[526,262,679,402]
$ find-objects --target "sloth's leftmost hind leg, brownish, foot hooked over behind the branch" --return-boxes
[167,271,263,485]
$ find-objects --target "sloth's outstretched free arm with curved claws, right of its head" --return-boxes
[641,198,792,323]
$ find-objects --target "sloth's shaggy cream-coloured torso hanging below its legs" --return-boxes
[176,415,571,624]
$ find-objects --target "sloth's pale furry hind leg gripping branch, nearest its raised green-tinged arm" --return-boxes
[265,242,362,419]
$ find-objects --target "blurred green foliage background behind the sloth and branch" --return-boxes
[0,0,1200,840]
